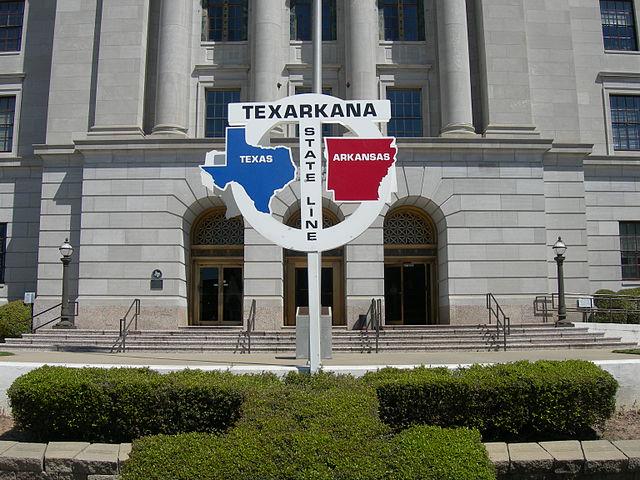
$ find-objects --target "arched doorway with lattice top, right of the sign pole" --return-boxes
[384,207,438,325]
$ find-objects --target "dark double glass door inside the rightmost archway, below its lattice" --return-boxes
[384,262,435,325]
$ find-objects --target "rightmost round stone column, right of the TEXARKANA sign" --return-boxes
[437,0,475,136]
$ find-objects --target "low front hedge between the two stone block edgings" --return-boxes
[120,425,496,480]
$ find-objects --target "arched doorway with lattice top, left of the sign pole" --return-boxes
[190,208,244,326]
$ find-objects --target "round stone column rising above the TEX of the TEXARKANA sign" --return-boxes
[249,0,282,102]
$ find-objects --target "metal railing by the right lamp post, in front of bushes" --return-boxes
[533,293,640,324]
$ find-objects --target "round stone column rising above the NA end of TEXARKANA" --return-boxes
[347,0,379,100]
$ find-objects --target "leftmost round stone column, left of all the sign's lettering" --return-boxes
[153,0,193,135]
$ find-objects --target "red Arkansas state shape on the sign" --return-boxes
[325,137,398,202]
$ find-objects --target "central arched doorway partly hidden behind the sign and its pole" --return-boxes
[284,208,346,326]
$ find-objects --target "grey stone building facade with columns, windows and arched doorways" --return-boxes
[0,0,640,330]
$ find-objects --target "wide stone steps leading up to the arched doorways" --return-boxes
[0,324,637,353]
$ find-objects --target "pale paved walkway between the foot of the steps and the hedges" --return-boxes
[0,346,640,368]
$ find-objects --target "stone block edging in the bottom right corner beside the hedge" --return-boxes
[484,440,640,479]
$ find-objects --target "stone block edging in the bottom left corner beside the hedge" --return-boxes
[0,441,131,480]
